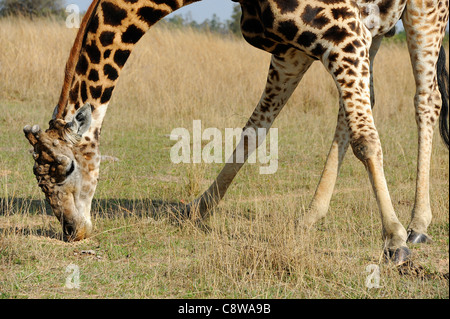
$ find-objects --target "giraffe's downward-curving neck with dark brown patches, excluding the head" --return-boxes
[55,0,200,143]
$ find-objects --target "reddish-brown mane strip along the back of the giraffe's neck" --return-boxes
[54,0,100,119]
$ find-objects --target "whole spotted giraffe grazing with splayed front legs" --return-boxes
[24,0,449,264]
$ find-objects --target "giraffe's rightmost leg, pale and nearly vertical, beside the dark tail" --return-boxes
[403,1,448,243]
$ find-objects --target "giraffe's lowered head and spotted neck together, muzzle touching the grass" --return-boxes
[20,0,186,241]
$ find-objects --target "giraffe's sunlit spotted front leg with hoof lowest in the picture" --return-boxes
[324,42,410,264]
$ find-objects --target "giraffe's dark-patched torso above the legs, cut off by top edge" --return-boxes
[240,0,406,58]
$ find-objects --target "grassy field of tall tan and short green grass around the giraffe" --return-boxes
[0,19,449,298]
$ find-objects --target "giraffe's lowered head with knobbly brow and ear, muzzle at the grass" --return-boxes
[23,104,97,241]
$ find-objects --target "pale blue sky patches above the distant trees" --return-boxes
[65,0,236,23]
